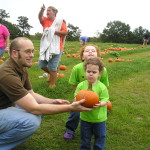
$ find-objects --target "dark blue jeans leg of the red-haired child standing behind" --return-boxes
[66,112,80,134]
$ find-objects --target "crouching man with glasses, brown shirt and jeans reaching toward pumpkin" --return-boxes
[0,37,91,150]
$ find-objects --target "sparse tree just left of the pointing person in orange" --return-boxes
[17,16,33,36]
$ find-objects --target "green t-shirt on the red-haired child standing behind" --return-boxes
[69,62,109,87]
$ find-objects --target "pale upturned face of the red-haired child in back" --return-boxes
[83,46,98,60]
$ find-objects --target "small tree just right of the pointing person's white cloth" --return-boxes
[66,24,81,41]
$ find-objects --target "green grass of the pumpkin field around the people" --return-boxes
[6,41,150,150]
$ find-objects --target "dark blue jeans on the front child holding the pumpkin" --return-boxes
[80,120,106,150]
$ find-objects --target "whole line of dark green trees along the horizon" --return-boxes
[0,9,150,44]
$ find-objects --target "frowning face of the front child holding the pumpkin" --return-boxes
[86,64,100,83]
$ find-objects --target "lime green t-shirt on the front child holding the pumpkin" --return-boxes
[74,80,109,123]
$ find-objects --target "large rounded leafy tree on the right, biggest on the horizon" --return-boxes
[100,21,132,43]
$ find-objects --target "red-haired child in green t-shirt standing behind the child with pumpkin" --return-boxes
[64,44,109,140]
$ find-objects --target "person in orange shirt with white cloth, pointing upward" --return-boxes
[38,4,68,88]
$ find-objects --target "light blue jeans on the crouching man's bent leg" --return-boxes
[0,107,41,150]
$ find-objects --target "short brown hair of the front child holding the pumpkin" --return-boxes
[84,57,104,72]
